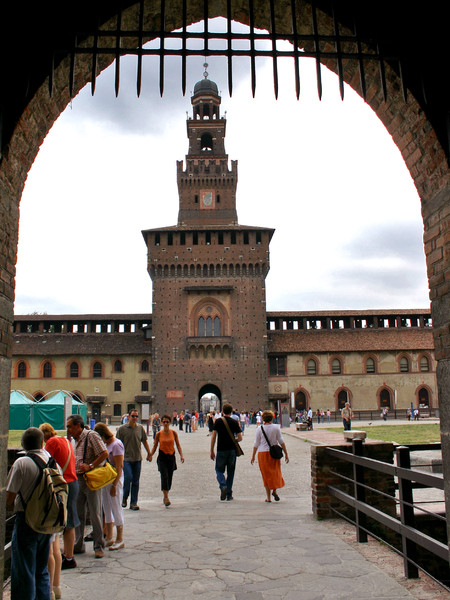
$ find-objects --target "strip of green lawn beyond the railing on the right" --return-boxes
[327,421,441,444]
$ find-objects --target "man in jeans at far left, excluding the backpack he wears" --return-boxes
[6,427,60,600]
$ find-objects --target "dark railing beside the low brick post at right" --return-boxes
[326,440,450,591]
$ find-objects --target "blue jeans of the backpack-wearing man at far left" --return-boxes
[11,512,52,600]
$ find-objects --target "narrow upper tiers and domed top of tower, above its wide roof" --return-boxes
[177,63,237,226]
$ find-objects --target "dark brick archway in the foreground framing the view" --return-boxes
[0,0,450,580]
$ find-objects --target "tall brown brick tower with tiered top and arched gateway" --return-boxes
[142,65,274,412]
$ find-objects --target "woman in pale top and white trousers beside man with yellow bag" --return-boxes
[94,423,125,550]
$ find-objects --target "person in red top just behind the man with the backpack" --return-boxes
[39,423,80,569]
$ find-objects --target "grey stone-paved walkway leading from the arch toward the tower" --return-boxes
[5,426,448,600]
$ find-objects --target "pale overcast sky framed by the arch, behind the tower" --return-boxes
[15,21,429,314]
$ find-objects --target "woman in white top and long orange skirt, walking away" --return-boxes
[251,410,289,502]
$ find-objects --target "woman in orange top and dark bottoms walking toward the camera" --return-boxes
[150,415,184,506]
